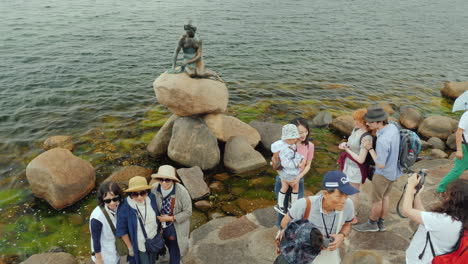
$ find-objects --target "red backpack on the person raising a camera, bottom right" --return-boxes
[419,229,468,264]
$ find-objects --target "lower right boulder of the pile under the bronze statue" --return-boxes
[224,136,267,173]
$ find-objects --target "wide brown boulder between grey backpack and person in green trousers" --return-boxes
[418,116,458,140]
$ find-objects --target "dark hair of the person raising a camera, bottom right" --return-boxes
[432,179,468,228]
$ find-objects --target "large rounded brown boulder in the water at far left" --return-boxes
[26,148,96,210]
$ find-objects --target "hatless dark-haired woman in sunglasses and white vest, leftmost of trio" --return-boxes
[89,182,123,264]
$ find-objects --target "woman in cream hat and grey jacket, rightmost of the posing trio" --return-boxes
[151,165,192,264]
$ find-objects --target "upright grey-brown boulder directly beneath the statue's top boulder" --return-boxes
[167,117,221,170]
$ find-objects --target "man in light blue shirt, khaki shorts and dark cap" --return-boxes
[353,105,403,232]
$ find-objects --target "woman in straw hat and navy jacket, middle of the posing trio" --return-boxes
[117,176,164,264]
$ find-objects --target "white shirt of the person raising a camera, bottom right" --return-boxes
[406,212,462,264]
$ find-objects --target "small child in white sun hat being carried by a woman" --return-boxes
[271,124,306,215]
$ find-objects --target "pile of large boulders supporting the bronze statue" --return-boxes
[151,73,266,173]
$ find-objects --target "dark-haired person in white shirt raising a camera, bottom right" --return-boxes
[402,173,468,264]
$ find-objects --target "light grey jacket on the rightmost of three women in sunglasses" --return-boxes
[151,182,192,256]
